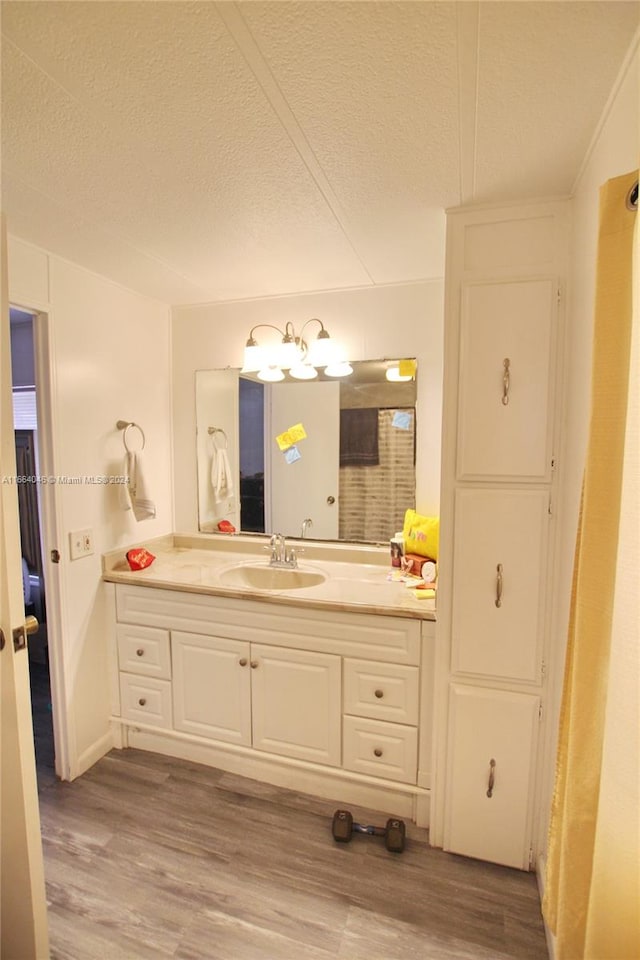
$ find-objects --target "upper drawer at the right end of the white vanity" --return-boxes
[344,660,418,725]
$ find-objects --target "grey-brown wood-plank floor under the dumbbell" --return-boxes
[35,750,547,960]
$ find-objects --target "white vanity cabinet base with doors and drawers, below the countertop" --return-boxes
[113,583,435,826]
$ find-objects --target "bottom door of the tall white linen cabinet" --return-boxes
[444,684,540,870]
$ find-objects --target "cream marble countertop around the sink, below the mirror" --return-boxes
[102,534,436,620]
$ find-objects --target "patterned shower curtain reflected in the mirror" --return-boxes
[339,409,416,541]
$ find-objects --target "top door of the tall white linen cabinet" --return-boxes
[457,279,557,481]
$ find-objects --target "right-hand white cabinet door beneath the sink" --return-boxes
[251,643,341,766]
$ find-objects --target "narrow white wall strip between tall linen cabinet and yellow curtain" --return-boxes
[541,38,640,837]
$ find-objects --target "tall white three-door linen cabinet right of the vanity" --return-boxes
[431,201,569,870]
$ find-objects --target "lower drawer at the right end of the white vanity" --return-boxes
[342,717,418,783]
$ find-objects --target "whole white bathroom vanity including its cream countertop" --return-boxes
[104,536,435,826]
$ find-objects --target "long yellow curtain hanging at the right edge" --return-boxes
[543,172,640,960]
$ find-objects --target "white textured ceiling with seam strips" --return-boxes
[2,0,640,303]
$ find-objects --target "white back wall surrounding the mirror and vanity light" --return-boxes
[172,281,444,533]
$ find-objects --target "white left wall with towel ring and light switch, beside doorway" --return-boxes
[9,239,173,776]
